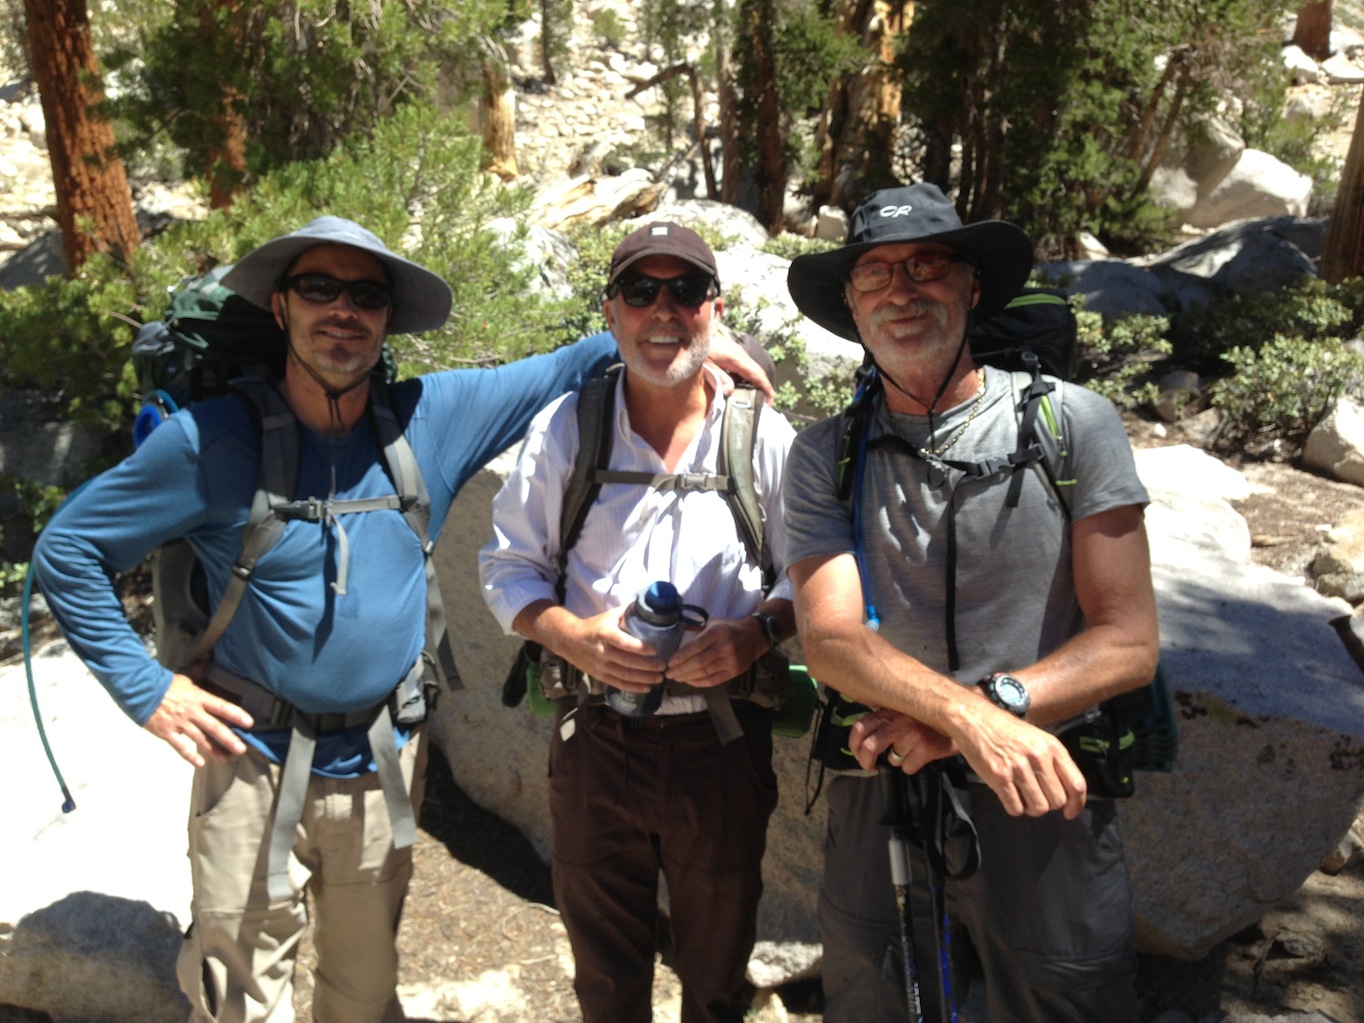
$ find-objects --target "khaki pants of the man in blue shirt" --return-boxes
[177,728,426,1023]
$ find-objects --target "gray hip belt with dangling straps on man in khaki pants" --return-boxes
[203,657,425,899]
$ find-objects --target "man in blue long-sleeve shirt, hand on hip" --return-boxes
[34,217,769,1023]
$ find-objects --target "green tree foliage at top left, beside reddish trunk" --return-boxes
[95,0,513,181]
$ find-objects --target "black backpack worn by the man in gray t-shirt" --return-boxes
[812,288,1178,805]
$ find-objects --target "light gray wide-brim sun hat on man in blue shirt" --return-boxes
[222,217,451,334]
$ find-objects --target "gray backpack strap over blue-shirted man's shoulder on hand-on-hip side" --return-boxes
[190,376,299,663]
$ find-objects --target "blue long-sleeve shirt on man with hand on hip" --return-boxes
[34,334,615,775]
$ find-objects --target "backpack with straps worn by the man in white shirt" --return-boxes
[502,366,813,739]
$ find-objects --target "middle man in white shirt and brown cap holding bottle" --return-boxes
[479,224,794,1023]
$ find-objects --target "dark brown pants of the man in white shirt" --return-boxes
[550,702,776,1023]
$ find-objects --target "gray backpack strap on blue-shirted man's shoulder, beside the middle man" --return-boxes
[370,376,464,689]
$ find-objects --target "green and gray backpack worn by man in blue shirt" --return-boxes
[132,266,460,687]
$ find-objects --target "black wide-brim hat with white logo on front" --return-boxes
[786,184,1033,341]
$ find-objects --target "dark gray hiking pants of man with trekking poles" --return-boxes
[820,776,1136,1023]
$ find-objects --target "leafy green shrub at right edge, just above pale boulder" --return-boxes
[1213,334,1364,454]
